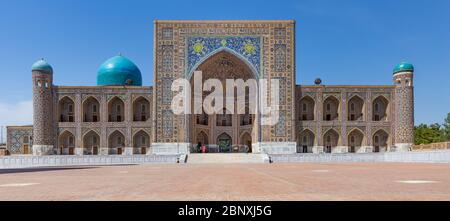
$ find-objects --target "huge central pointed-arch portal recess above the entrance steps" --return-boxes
[187,50,259,152]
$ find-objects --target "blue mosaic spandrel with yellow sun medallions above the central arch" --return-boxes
[186,36,262,77]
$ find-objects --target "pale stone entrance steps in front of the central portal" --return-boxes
[187,153,269,164]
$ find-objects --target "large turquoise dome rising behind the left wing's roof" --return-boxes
[97,55,142,86]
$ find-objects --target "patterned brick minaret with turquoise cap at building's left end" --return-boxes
[31,59,54,156]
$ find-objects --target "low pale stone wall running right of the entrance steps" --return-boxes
[269,150,450,163]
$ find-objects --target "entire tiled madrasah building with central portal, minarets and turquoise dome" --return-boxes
[7,20,414,155]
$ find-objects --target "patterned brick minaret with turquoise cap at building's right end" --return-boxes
[393,62,414,151]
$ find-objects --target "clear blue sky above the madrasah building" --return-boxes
[0,0,450,129]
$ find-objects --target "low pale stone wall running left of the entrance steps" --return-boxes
[0,155,180,169]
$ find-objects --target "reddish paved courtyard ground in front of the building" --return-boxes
[0,163,450,200]
